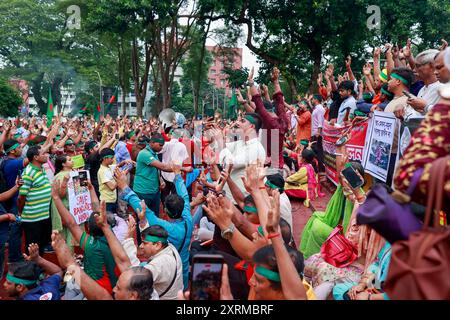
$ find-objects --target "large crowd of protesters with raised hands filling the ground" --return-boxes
[0,41,450,300]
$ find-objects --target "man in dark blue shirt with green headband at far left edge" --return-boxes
[0,139,29,262]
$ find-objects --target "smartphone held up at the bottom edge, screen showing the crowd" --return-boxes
[190,254,224,300]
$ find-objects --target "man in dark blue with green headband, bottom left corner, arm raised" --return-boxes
[3,243,63,300]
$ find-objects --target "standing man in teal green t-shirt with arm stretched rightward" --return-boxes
[133,133,183,218]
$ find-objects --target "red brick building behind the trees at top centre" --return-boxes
[206,46,242,97]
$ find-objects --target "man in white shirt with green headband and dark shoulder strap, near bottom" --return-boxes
[122,225,183,300]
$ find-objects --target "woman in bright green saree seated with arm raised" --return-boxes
[299,146,365,259]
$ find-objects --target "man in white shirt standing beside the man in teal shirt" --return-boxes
[161,128,189,202]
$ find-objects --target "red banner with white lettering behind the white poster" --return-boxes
[322,119,369,185]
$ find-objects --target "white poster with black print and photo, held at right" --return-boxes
[362,111,397,182]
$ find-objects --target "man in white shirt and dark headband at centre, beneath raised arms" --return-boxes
[219,112,266,195]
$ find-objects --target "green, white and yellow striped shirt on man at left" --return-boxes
[19,163,52,222]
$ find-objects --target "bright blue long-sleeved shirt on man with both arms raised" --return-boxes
[119,174,194,289]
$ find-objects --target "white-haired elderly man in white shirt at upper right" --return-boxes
[408,49,443,115]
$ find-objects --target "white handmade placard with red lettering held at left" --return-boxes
[67,171,92,224]
